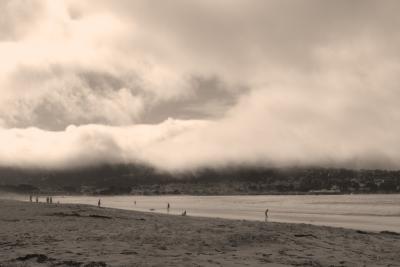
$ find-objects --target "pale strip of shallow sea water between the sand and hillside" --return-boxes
[39,194,400,232]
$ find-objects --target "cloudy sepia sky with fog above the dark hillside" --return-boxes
[0,0,400,171]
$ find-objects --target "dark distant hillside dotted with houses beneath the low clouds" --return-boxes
[0,165,400,195]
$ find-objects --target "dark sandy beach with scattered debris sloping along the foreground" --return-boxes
[0,200,400,266]
